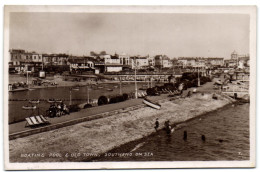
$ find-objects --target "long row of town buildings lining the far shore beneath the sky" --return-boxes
[9,49,250,74]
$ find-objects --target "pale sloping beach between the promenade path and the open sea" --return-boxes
[9,94,230,162]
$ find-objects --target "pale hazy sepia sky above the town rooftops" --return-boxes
[9,12,250,58]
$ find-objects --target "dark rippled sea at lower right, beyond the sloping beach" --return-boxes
[92,104,250,161]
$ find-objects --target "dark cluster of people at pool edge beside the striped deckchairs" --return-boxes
[47,102,70,118]
